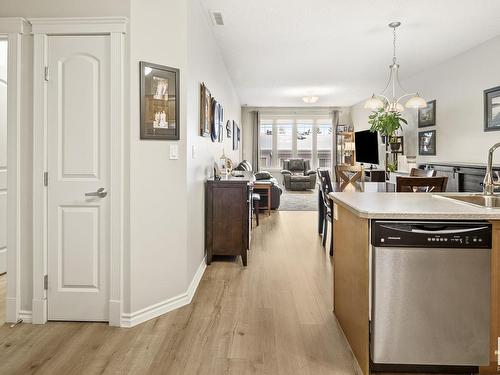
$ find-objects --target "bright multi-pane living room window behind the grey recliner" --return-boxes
[259,114,333,168]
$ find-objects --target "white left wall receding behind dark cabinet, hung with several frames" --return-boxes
[186,0,241,283]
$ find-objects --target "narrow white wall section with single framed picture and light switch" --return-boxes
[125,0,187,312]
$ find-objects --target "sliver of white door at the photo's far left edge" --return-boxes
[0,39,7,274]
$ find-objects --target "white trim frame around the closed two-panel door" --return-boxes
[29,17,127,326]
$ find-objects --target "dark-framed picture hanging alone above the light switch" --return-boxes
[139,61,180,140]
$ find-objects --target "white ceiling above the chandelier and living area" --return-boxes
[197,0,500,106]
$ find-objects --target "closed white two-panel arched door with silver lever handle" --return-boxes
[47,35,110,321]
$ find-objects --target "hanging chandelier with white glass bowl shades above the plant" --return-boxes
[365,22,427,112]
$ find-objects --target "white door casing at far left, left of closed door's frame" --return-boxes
[0,17,31,322]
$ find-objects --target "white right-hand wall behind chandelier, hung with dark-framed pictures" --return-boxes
[351,36,500,163]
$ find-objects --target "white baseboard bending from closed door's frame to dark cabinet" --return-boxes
[120,259,207,327]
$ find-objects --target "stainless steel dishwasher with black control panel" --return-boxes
[370,220,491,370]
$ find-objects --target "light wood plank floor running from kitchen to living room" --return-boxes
[0,212,355,375]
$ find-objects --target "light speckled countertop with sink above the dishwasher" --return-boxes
[329,192,500,220]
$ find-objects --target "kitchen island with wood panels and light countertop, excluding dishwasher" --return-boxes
[329,192,500,374]
